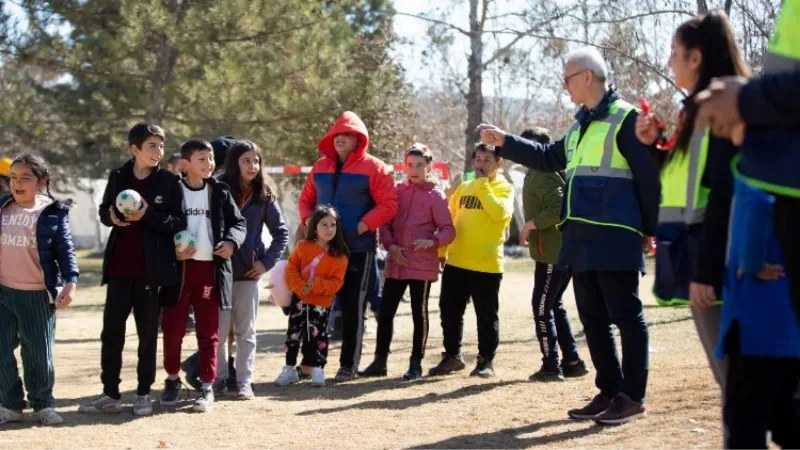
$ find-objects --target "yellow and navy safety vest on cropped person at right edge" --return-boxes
[734,0,800,198]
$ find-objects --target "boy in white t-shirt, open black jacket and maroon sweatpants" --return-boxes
[156,140,246,412]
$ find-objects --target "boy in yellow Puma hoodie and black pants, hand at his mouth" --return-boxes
[429,144,514,378]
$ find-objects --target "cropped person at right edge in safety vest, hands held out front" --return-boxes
[697,0,800,326]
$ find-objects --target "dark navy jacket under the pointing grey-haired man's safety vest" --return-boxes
[498,89,661,272]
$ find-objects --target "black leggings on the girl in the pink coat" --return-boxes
[375,278,431,359]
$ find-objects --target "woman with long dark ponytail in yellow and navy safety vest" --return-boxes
[636,11,750,446]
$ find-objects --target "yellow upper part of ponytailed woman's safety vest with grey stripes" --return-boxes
[658,127,710,225]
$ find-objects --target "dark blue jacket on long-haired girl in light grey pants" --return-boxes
[233,197,289,280]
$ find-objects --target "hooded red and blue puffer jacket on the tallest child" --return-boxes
[298,111,397,253]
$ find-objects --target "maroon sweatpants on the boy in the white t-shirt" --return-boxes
[161,260,219,383]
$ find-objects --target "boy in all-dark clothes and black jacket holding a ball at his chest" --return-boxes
[79,123,186,416]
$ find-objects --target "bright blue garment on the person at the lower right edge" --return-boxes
[717,180,800,359]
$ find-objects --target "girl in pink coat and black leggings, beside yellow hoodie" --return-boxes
[359,144,456,380]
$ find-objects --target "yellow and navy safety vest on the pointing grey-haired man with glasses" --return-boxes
[560,100,642,235]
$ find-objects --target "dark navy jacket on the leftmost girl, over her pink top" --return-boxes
[0,194,80,307]
